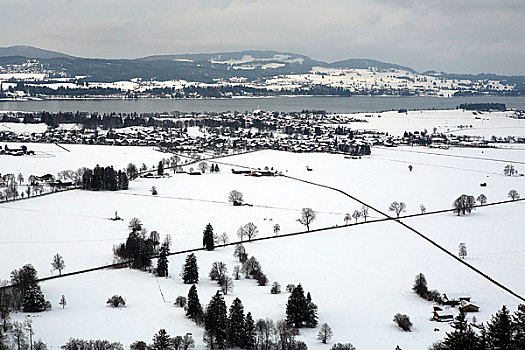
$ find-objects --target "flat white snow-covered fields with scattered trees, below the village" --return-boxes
[0,112,525,350]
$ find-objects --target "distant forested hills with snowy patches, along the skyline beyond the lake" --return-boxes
[0,45,525,86]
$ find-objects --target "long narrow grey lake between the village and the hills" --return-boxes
[0,96,525,113]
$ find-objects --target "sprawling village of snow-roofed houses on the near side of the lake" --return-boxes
[0,111,374,155]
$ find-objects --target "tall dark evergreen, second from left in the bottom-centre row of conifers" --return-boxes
[204,291,228,349]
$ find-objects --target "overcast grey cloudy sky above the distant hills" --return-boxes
[0,0,525,74]
